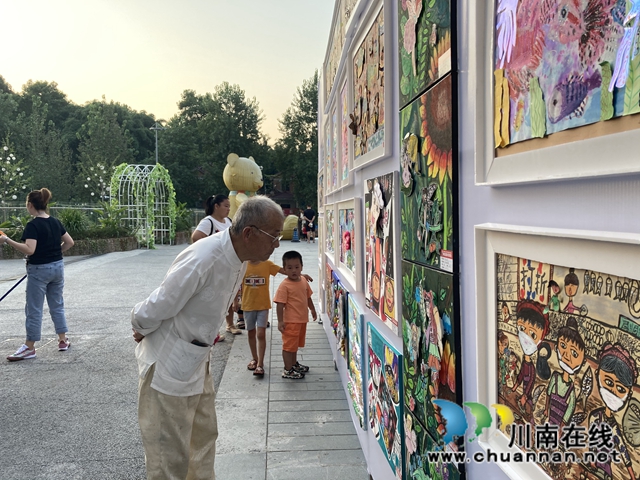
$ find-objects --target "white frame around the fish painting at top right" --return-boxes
[466,1,640,186]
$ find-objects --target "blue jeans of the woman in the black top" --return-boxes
[24,260,68,342]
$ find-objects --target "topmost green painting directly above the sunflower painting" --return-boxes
[398,0,451,108]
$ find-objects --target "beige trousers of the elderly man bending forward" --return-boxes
[138,363,218,480]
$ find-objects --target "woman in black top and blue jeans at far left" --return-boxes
[0,188,73,362]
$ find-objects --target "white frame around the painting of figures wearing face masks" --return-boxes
[474,223,640,480]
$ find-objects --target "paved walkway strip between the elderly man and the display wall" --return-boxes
[216,242,369,480]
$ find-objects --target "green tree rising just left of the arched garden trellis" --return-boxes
[76,99,134,201]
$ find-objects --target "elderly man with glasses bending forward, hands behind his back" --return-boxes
[131,196,284,480]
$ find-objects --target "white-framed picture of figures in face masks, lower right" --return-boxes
[475,224,640,479]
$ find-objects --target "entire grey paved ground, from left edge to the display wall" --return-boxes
[0,241,368,480]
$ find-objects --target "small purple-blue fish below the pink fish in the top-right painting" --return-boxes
[547,70,602,123]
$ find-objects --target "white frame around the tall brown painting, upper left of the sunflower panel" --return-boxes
[346,1,397,170]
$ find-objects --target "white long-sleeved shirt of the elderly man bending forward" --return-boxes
[131,229,247,397]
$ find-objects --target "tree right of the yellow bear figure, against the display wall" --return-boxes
[274,70,318,205]
